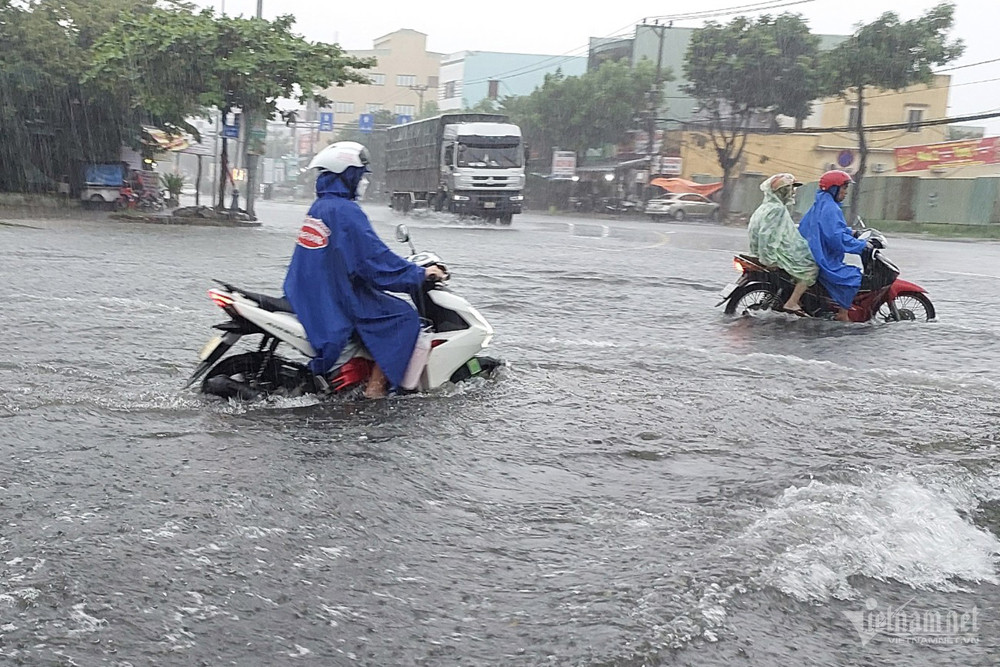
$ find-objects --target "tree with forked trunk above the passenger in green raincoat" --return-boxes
[684,14,820,210]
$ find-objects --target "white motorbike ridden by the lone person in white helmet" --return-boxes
[187,225,503,400]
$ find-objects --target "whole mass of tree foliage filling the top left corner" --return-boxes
[0,0,372,197]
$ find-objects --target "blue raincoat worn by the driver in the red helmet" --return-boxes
[799,190,868,308]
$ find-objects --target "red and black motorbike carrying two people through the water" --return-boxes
[716,224,936,322]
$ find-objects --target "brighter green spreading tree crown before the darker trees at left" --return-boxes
[87,8,374,137]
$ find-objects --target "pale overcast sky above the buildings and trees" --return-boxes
[195,0,1000,134]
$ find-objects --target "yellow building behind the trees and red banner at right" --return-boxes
[667,75,951,182]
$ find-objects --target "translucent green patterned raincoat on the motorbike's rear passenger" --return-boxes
[747,176,819,285]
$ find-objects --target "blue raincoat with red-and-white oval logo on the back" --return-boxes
[284,172,424,387]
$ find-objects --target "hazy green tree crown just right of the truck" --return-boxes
[499,60,672,166]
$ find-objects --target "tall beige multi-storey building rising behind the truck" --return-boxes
[321,28,443,135]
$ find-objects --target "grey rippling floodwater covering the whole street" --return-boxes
[0,202,1000,666]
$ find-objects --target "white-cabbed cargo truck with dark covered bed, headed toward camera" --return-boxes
[385,113,525,225]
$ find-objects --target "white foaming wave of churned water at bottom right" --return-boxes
[743,473,1000,601]
